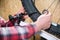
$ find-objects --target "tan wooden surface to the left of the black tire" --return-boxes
[0,0,22,20]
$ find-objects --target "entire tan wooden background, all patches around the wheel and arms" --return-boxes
[0,0,60,40]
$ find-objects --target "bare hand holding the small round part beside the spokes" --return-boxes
[35,13,51,31]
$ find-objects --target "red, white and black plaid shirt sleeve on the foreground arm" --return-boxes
[0,18,35,40]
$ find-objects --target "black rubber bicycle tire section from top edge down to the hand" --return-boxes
[21,0,41,21]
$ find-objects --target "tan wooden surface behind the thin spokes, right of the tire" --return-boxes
[35,0,60,24]
